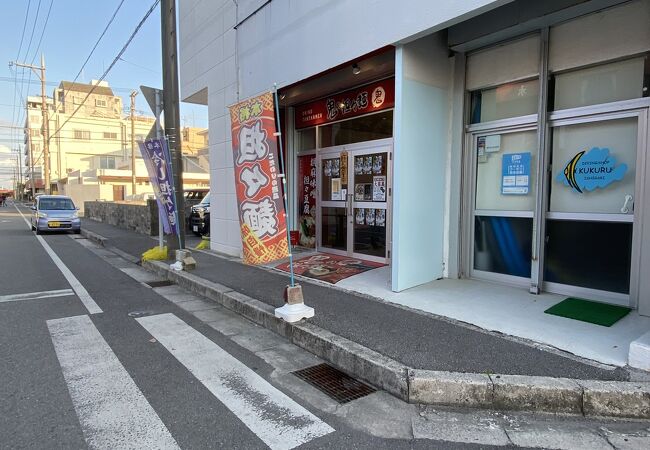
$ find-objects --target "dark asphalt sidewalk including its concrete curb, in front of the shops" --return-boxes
[82,220,650,420]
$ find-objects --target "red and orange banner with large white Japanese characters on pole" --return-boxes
[230,92,289,264]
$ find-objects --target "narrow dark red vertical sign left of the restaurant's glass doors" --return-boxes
[298,155,316,248]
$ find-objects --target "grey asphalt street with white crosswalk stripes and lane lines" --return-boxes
[0,203,648,449]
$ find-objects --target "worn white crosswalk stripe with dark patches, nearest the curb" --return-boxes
[136,314,334,449]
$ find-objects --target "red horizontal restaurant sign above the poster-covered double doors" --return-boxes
[295,78,395,129]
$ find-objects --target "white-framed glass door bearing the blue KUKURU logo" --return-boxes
[544,111,646,306]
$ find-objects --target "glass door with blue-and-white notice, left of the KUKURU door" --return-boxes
[471,127,538,285]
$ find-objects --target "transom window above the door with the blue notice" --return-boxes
[470,79,539,123]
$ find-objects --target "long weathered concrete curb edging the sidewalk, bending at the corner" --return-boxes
[142,261,650,419]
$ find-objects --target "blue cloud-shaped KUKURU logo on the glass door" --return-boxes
[556,147,627,194]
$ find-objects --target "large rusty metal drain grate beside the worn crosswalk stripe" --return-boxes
[293,364,375,403]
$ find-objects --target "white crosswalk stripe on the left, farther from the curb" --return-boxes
[47,316,179,449]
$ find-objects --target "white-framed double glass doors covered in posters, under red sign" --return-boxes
[317,142,392,263]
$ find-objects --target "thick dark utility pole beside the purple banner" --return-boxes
[160,0,185,250]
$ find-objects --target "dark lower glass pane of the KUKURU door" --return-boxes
[544,220,632,294]
